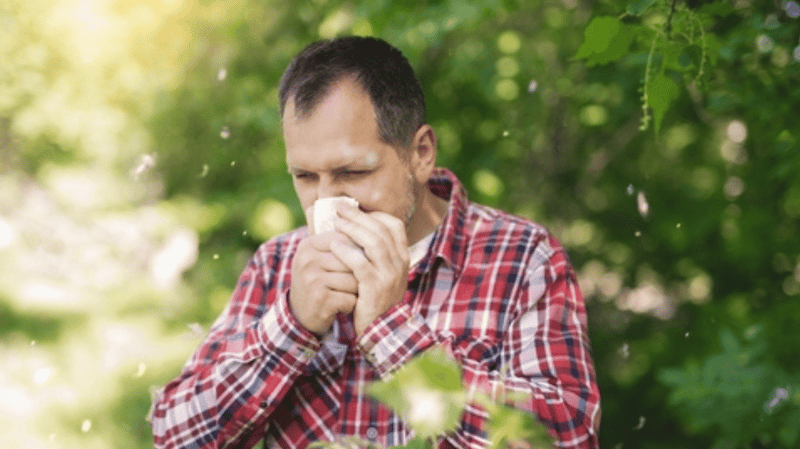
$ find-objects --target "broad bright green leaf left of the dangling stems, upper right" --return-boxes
[573,16,634,66]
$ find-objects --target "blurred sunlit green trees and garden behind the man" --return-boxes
[0,0,800,448]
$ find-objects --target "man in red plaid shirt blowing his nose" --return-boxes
[152,37,599,448]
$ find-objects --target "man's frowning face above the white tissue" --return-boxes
[283,80,415,228]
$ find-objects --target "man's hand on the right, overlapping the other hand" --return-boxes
[331,205,410,336]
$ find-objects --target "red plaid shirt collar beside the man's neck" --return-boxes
[420,168,469,271]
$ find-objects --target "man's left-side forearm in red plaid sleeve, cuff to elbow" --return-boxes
[152,288,319,448]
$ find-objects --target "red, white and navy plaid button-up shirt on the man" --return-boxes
[152,169,600,448]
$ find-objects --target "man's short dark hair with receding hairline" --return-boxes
[279,36,426,148]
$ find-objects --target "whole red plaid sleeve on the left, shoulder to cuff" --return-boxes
[152,244,320,449]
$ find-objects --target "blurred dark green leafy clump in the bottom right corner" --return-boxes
[659,325,800,448]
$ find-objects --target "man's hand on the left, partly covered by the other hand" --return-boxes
[289,208,358,336]
